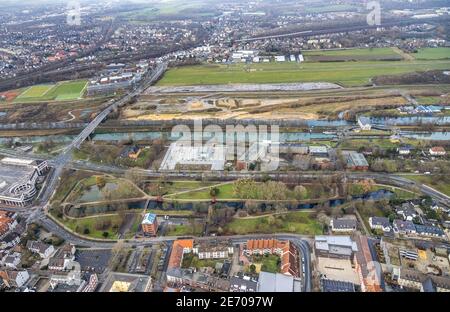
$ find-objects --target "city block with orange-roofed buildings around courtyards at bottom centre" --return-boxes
[166,239,302,292]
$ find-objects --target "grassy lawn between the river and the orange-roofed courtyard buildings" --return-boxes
[224,211,323,235]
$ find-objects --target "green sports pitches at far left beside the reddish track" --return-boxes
[14,80,87,103]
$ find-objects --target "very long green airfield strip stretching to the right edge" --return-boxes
[158,60,450,86]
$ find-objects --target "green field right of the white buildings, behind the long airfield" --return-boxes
[303,48,403,62]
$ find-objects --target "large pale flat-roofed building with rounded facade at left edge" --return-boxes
[0,157,48,207]
